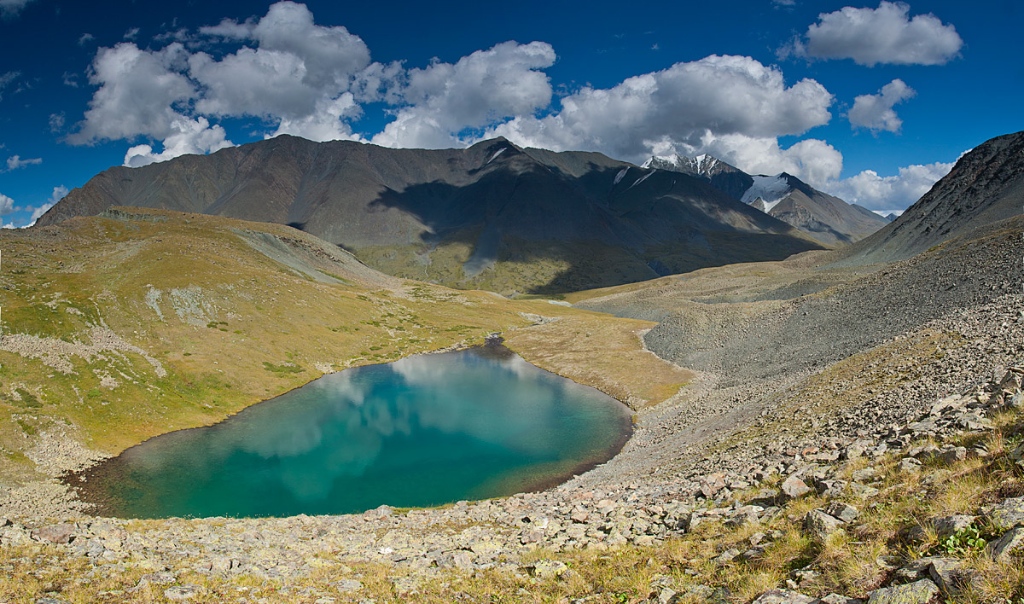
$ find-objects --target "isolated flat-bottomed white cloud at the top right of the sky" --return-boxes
[779,1,964,67]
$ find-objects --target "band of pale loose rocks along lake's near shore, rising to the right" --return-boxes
[0,295,1024,602]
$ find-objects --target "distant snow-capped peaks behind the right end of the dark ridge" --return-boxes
[643,155,889,247]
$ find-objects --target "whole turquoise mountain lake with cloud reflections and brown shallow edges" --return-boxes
[71,346,632,518]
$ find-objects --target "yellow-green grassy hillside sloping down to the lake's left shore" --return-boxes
[0,210,686,482]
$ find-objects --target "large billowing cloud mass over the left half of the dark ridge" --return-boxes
[68,1,376,166]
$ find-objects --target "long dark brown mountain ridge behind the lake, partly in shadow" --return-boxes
[38,136,822,294]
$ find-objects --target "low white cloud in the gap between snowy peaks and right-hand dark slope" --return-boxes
[823,162,954,215]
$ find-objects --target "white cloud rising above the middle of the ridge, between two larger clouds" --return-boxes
[373,42,556,147]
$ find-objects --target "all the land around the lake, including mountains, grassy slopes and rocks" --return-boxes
[0,133,1024,604]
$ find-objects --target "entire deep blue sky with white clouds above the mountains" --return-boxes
[0,0,1024,226]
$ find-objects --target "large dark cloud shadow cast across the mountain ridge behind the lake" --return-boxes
[371,152,819,296]
